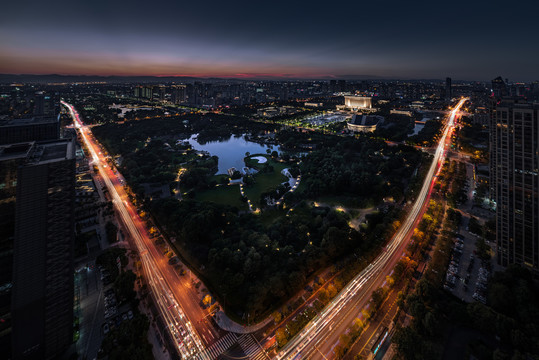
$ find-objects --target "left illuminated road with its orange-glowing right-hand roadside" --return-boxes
[62,101,217,359]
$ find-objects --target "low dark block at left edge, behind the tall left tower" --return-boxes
[0,115,60,144]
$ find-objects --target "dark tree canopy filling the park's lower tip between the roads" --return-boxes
[153,200,368,316]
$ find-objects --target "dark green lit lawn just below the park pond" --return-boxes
[245,154,290,207]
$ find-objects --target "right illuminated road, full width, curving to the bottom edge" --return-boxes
[277,99,467,360]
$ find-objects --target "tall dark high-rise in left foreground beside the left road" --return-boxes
[12,139,75,359]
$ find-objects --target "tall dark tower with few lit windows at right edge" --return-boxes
[490,100,539,274]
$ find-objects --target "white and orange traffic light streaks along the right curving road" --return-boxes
[277,98,468,359]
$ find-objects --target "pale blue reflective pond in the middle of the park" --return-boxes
[188,134,280,174]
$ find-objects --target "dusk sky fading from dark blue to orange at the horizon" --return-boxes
[0,0,539,81]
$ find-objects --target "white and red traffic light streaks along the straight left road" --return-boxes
[61,101,207,359]
